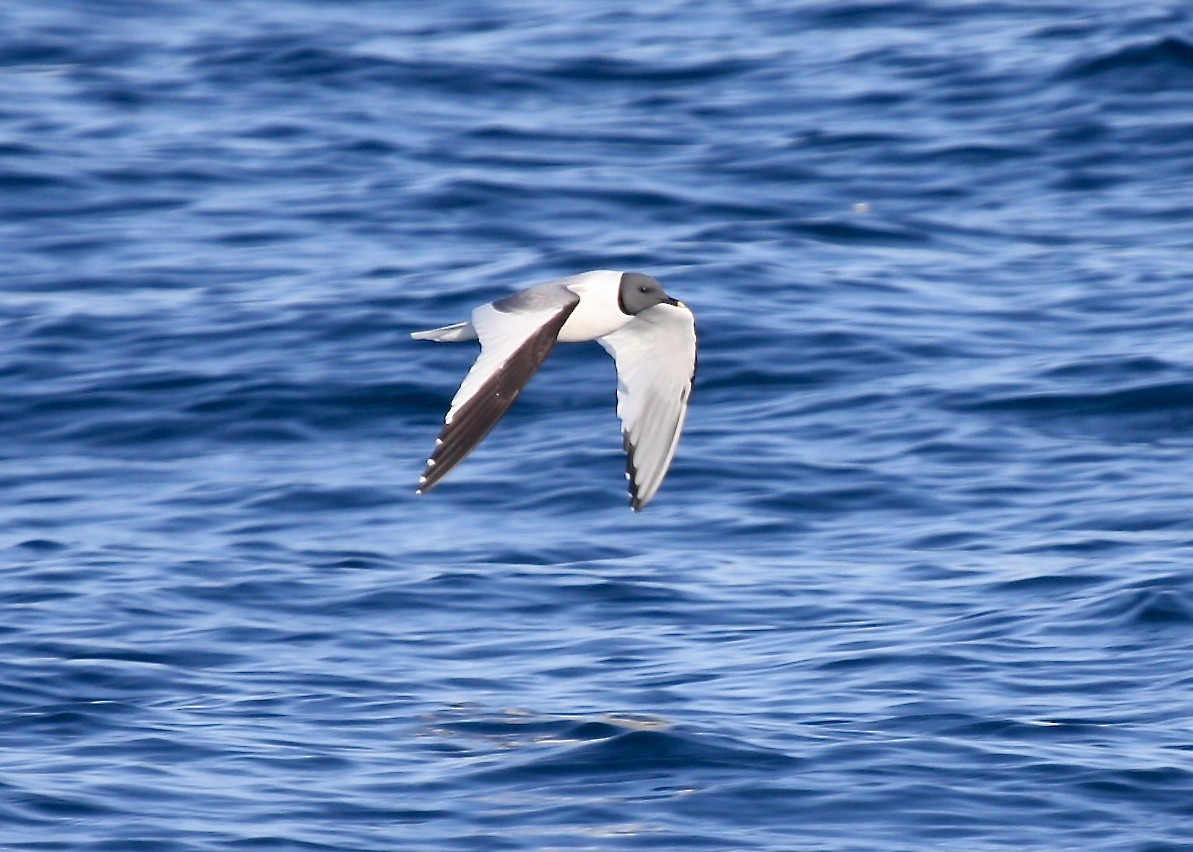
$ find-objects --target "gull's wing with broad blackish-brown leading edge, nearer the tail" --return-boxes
[419,286,580,494]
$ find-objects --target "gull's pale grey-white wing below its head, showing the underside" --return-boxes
[599,304,696,512]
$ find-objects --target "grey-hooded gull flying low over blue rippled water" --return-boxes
[410,270,696,512]
